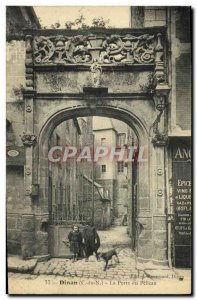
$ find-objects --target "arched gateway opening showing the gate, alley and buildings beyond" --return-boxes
[45,116,139,257]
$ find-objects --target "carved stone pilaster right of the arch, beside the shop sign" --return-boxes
[152,86,169,265]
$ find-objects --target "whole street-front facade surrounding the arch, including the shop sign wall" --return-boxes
[7,7,191,267]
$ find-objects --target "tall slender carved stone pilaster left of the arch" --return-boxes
[21,36,36,258]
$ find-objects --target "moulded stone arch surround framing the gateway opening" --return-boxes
[34,104,152,259]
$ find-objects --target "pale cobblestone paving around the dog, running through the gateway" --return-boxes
[10,226,143,279]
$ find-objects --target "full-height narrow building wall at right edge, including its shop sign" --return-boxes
[168,7,192,267]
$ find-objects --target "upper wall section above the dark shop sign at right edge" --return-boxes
[169,7,192,132]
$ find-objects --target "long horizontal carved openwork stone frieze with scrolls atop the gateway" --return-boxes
[33,34,159,64]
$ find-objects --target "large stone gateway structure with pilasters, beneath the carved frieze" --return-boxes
[22,28,169,263]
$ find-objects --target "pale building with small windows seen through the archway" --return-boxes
[93,117,137,224]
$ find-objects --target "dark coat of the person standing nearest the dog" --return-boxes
[83,225,100,257]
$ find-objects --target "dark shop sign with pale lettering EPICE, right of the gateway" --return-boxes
[173,141,192,267]
